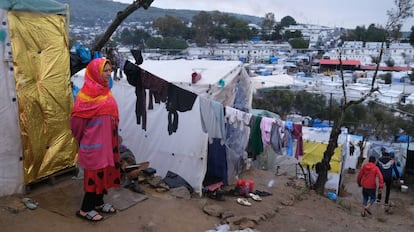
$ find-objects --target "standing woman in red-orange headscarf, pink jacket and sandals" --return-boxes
[70,58,121,222]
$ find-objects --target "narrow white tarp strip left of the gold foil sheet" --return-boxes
[0,9,23,196]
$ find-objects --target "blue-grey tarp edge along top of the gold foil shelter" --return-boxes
[0,0,66,14]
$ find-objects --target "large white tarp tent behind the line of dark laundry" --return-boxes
[72,60,252,191]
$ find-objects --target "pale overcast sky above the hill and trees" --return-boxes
[113,0,414,31]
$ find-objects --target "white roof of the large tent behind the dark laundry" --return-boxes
[140,59,252,108]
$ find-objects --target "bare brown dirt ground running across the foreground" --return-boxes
[0,169,414,232]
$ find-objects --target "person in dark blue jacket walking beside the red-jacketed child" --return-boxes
[377,149,400,210]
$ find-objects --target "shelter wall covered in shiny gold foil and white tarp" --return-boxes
[0,0,77,196]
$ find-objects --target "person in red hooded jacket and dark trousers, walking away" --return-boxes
[357,156,384,217]
